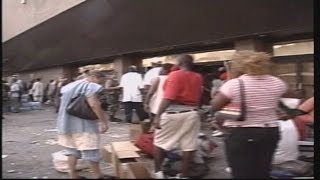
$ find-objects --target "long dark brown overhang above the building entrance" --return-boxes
[3,0,313,72]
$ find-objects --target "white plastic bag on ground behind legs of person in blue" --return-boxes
[52,151,89,172]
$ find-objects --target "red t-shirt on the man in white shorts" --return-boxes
[163,70,203,106]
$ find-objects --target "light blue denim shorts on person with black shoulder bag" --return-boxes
[64,148,101,162]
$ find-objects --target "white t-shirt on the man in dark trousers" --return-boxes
[120,72,143,102]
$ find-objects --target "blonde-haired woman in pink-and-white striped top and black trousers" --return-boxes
[211,51,287,179]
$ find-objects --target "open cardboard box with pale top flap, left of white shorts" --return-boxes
[111,141,140,177]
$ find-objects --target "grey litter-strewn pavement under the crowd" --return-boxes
[2,107,230,179]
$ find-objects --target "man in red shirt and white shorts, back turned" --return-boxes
[154,55,203,179]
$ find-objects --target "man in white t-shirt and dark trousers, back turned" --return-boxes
[120,66,148,123]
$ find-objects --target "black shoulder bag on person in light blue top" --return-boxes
[66,83,98,120]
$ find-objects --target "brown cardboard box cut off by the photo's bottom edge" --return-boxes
[120,162,152,179]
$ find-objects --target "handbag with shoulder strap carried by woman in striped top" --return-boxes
[215,79,246,121]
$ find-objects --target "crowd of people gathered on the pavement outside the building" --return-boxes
[3,51,314,179]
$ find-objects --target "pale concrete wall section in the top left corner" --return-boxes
[2,0,85,42]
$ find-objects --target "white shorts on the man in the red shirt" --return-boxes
[154,111,201,151]
